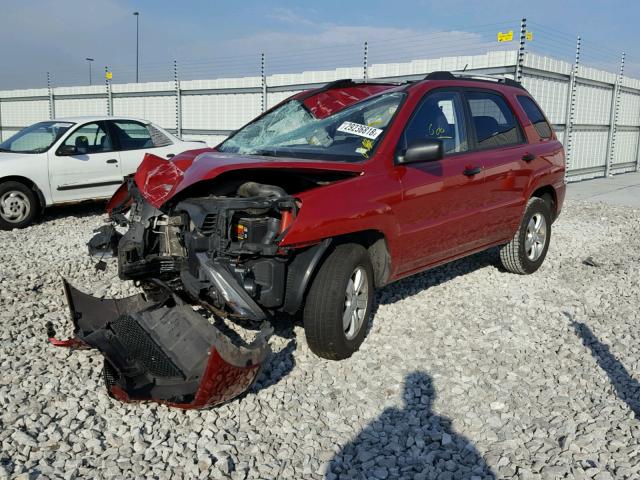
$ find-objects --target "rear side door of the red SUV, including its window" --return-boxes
[465,89,531,243]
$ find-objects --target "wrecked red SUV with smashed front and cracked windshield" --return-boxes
[51,72,565,405]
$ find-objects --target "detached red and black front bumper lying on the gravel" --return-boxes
[48,280,273,409]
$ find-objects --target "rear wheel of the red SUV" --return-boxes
[500,197,552,275]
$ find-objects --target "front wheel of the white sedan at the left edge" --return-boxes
[0,182,39,230]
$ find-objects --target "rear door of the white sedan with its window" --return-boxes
[108,120,180,176]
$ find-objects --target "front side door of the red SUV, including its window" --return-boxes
[395,89,486,273]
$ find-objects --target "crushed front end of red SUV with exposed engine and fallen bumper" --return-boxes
[49,155,319,408]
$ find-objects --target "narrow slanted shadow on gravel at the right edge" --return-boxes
[571,320,640,419]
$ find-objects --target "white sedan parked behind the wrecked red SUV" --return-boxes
[0,117,206,230]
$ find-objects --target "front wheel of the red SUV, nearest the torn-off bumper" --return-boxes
[303,243,374,360]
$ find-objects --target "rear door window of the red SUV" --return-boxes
[466,92,523,149]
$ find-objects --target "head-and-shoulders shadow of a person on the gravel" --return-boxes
[326,371,496,480]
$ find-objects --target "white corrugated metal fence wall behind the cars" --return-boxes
[0,51,640,180]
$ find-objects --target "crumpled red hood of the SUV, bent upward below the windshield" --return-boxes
[134,149,363,208]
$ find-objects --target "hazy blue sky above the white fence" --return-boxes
[0,0,640,90]
